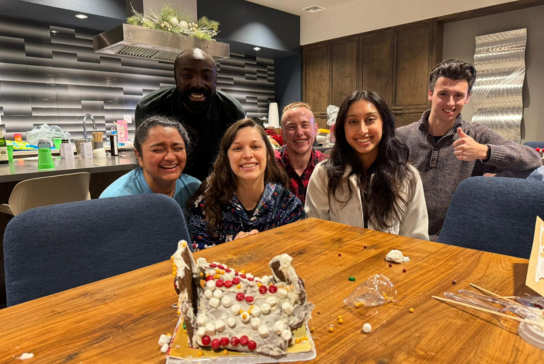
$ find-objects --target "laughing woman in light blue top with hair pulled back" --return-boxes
[100,116,200,211]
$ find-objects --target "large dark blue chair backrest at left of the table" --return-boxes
[4,194,191,306]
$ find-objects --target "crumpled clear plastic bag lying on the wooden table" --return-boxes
[344,274,397,308]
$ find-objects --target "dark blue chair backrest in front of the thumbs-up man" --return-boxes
[438,177,544,259]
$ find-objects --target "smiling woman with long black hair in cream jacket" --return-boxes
[306,91,428,240]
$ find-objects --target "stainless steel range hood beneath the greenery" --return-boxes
[93,24,230,63]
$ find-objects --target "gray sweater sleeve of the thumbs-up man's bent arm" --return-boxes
[467,123,542,174]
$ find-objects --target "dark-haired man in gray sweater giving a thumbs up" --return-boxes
[397,59,542,240]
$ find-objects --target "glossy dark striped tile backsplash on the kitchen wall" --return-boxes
[0,17,275,139]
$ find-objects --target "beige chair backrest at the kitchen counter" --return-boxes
[9,172,91,216]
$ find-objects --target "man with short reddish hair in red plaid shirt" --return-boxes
[274,102,329,204]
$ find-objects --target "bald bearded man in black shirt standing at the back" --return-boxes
[136,48,245,181]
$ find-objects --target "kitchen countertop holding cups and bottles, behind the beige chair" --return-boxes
[0,151,138,183]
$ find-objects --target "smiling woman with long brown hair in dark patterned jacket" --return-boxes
[189,119,305,251]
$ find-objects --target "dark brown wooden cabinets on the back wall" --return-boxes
[303,20,442,127]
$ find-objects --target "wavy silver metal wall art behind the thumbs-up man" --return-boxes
[472,29,527,143]
